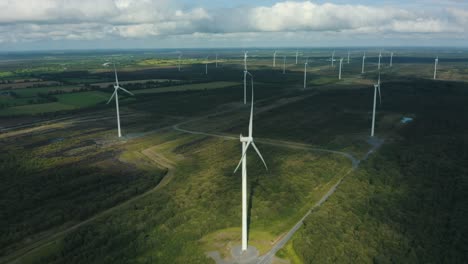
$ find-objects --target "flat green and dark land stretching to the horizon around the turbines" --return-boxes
[0,49,468,264]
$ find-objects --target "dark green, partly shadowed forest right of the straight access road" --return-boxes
[281,79,468,263]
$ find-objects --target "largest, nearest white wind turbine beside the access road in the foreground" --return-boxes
[234,73,268,251]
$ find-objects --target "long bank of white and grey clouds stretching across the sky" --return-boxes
[0,0,468,43]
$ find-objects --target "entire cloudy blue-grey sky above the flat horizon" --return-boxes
[0,0,468,52]
